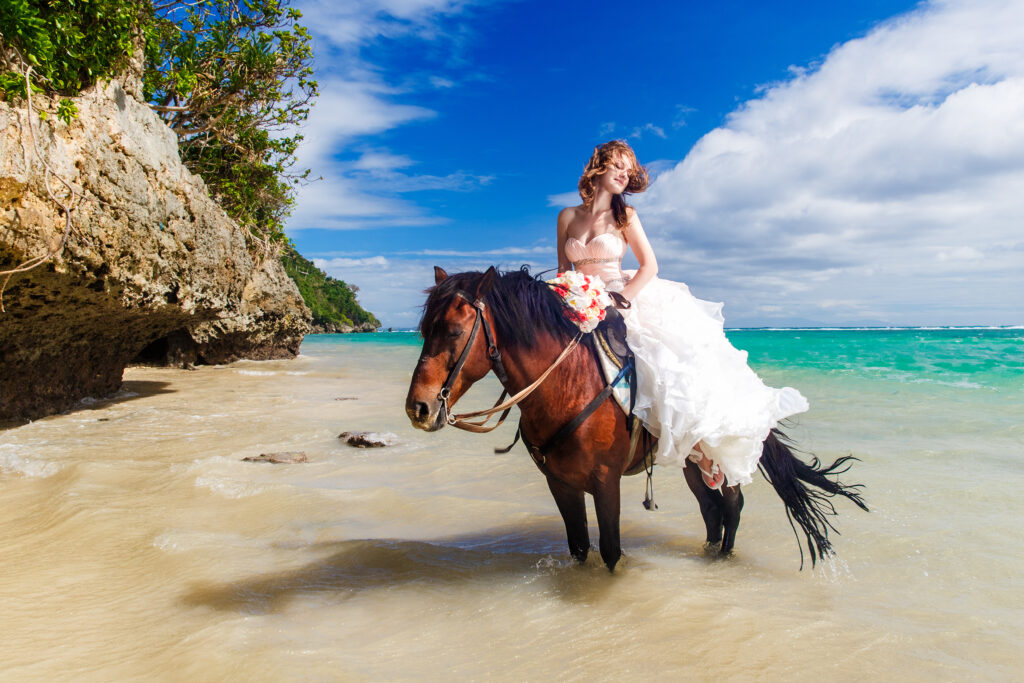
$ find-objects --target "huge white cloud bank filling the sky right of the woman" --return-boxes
[636,0,1024,324]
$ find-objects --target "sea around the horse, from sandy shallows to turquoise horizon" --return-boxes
[0,330,1024,680]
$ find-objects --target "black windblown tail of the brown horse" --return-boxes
[760,429,867,569]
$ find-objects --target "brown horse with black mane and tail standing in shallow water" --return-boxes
[406,267,867,569]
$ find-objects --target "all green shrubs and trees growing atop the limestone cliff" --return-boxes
[0,0,317,248]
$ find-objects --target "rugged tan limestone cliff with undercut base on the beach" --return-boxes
[0,82,309,420]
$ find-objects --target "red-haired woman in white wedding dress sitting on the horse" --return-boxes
[558,140,808,489]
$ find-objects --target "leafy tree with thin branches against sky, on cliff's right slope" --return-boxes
[144,0,317,245]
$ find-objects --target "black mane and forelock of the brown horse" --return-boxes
[420,265,580,348]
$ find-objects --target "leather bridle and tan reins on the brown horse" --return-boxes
[437,290,583,433]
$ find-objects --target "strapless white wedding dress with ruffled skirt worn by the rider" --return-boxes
[565,232,808,485]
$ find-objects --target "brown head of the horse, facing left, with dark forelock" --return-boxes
[406,266,498,431]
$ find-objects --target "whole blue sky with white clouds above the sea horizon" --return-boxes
[287,0,1024,328]
